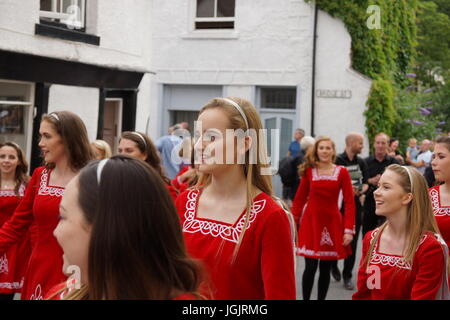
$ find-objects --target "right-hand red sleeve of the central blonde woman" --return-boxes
[261,210,296,300]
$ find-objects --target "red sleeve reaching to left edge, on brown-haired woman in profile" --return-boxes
[0,168,43,253]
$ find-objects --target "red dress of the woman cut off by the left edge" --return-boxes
[0,185,31,294]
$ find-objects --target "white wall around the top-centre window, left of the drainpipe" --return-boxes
[153,0,314,131]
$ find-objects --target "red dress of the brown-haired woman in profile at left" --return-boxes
[0,167,66,300]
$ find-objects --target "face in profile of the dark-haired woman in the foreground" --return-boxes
[53,176,91,283]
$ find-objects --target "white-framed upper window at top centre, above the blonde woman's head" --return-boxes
[195,0,236,29]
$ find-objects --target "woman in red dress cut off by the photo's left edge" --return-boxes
[0,142,31,300]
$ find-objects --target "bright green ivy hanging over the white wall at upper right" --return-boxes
[305,0,418,144]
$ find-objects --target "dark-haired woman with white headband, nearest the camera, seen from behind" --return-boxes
[47,155,200,300]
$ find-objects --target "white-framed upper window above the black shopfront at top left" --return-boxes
[39,0,86,30]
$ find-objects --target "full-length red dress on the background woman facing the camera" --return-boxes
[292,165,355,260]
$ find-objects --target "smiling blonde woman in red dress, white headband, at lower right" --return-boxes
[353,164,449,300]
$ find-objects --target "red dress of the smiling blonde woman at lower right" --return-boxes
[352,228,445,300]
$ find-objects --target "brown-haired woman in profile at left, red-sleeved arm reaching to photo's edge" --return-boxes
[0,111,94,300]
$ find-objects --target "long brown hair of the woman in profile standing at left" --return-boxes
[42,111,95,171]
